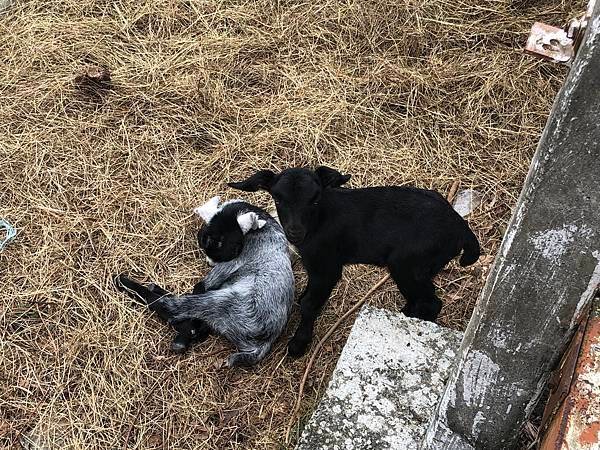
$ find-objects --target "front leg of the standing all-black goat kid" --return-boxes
[288,266,342,358]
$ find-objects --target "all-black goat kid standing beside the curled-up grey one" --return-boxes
[229,166,480,356]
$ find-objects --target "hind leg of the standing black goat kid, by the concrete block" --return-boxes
[389,266,442,322]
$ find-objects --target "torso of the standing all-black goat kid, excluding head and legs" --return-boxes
[308,186,474,270]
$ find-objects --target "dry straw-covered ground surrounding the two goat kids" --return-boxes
[0,0,580,449]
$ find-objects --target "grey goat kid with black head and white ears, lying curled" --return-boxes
[116,197,294,367]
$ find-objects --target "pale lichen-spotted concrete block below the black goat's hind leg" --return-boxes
[296,307,462,450]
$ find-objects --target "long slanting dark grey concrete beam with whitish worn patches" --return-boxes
[422,1,600,450]
